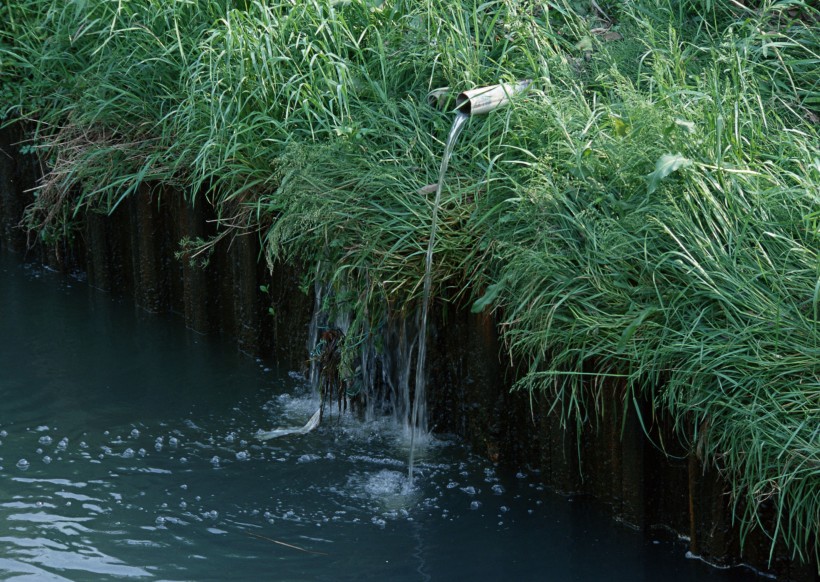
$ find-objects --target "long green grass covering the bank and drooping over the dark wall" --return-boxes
[0,0,820,565]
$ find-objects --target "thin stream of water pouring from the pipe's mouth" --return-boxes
[408,111,469,487]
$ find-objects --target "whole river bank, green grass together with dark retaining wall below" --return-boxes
[0,0,820,574]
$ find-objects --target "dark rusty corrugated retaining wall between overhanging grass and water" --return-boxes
[0,121,818,581]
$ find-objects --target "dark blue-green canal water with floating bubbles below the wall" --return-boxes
[0,252,754,582]
